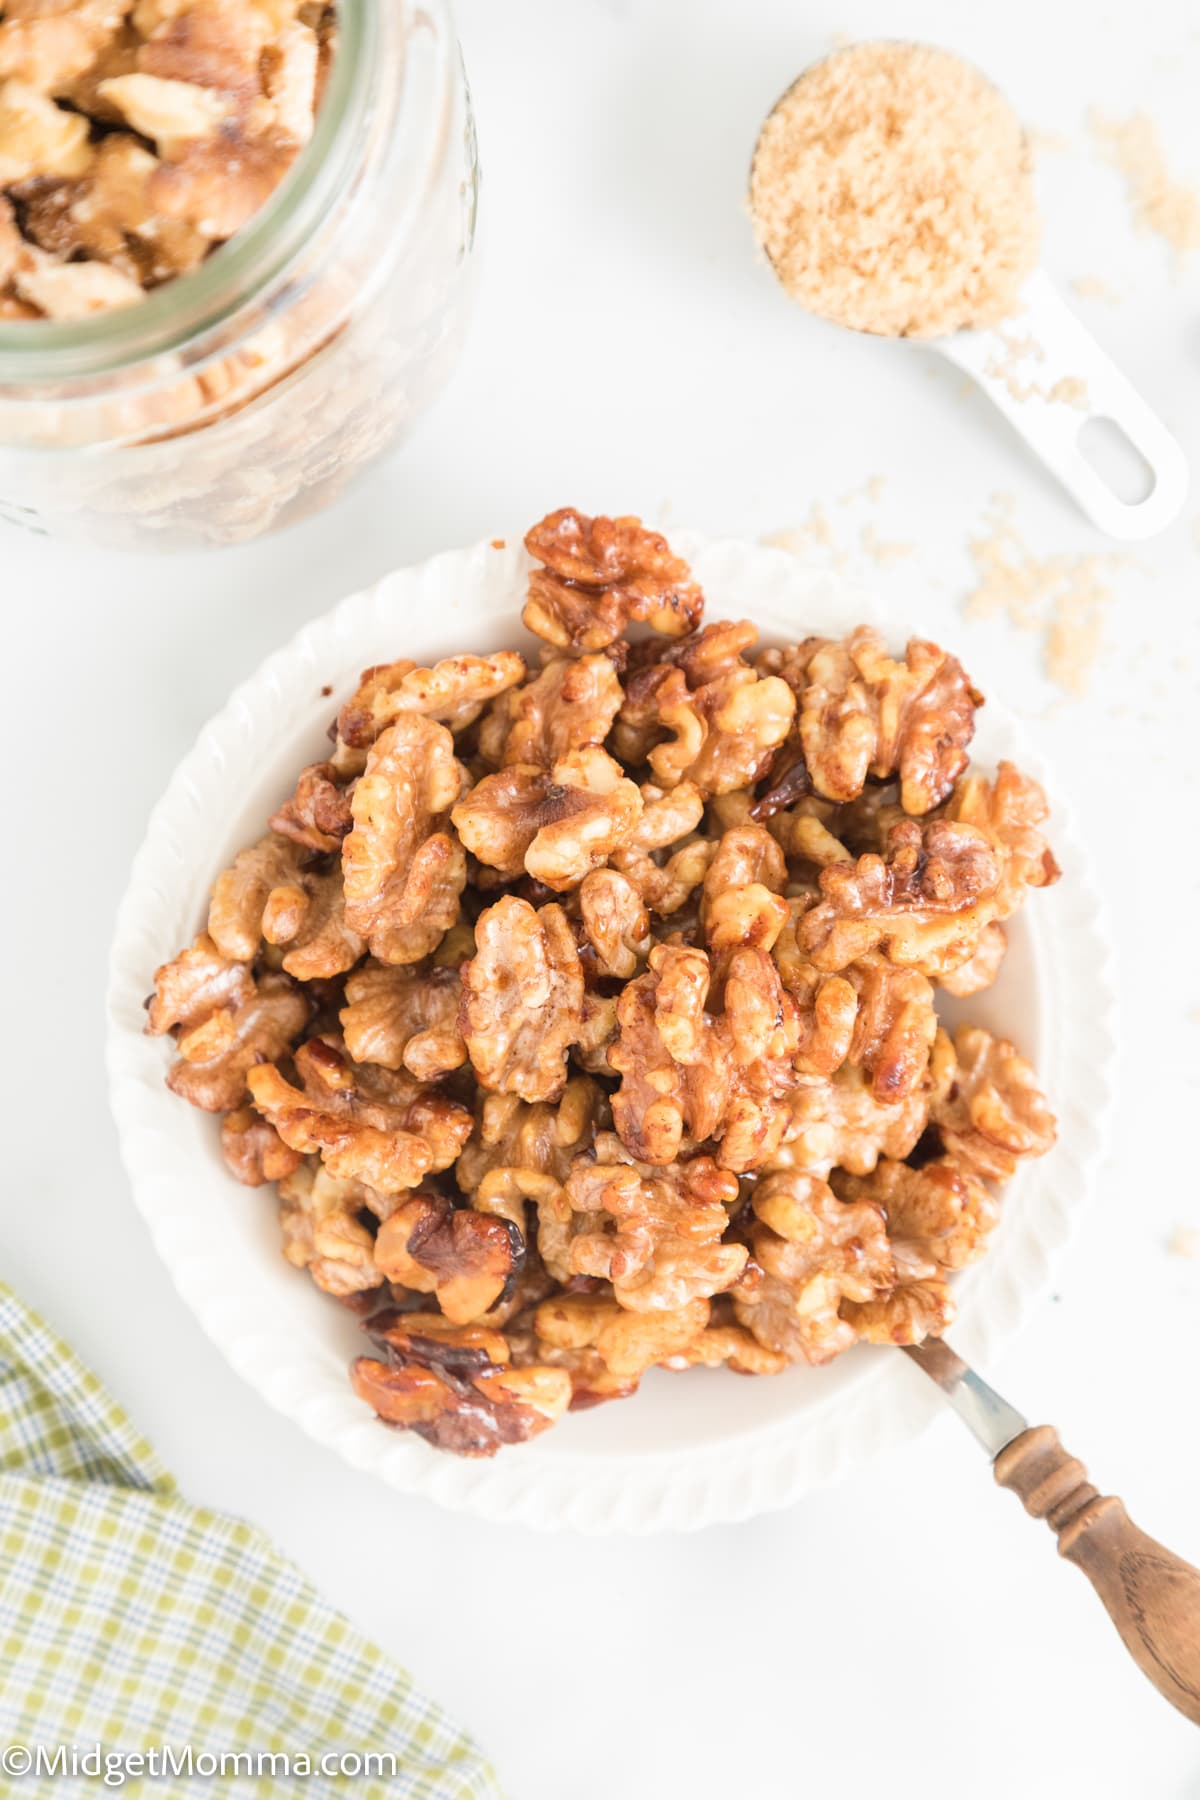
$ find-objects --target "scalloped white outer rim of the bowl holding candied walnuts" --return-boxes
[106,531,1115,1534]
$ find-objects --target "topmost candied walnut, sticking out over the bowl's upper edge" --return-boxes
[522,506,703,650]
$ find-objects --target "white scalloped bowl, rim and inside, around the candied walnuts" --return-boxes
[108,533,1112,1532]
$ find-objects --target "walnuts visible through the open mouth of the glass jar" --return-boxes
[0,0,336,322]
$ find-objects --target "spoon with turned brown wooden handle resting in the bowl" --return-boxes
[903,1337,1200,1724]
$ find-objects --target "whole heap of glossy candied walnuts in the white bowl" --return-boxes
[149,509,1058,1456]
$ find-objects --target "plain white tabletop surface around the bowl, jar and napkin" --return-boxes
[0,0,1200,1800]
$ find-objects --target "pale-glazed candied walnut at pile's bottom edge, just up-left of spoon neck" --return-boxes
[732,1170,894,1363]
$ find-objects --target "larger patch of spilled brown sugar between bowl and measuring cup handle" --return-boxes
[964,495,1128,697]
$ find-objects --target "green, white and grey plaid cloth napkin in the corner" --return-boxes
[0,1283,498,1800]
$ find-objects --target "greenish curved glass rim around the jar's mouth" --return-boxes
[0,0,381,392]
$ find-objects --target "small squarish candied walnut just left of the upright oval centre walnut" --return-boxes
[338,963,466,1082]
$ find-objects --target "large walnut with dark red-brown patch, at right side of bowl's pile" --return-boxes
[797,819,1002,979]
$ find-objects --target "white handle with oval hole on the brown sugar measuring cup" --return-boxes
[927,270,1187,542]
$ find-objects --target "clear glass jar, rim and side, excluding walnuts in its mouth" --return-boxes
[0,0,479,549]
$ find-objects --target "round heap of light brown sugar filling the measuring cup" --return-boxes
[750,43,1040,337]
